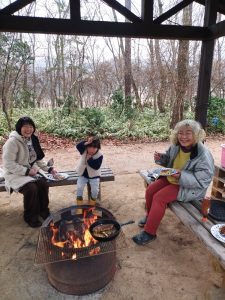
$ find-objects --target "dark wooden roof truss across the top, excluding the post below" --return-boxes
[0,0,225,40]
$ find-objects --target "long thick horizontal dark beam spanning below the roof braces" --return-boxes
[0,15,209,40]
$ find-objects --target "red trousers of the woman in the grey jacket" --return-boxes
[144,177,179,235]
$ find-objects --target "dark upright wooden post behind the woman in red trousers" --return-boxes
[195,0,217,128]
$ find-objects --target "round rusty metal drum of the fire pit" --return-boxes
[42,205,116,295]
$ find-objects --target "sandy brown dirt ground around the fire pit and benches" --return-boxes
[0,138,225,300]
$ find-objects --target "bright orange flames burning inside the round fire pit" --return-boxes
[50,208,100,255]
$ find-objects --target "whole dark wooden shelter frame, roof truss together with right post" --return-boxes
[0,0,225,127]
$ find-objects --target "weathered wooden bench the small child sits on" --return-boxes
[0,167,115,199]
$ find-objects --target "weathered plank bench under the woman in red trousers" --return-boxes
[139,167,225,282]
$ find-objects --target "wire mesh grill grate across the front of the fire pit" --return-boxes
[35,227,127,265]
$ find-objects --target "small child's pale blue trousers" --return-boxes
[77,176,100,199]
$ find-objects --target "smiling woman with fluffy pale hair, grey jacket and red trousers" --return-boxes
[133,120,214,245]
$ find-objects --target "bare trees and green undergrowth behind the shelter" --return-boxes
[0,0,225,144]
